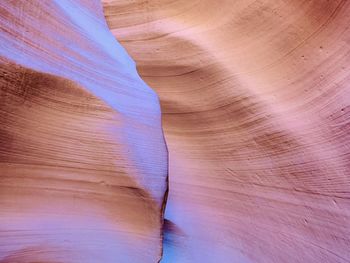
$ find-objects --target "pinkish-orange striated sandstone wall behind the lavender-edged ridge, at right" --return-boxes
[103,0,350,263]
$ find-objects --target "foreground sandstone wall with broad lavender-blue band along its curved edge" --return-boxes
[0,0,168,263]
